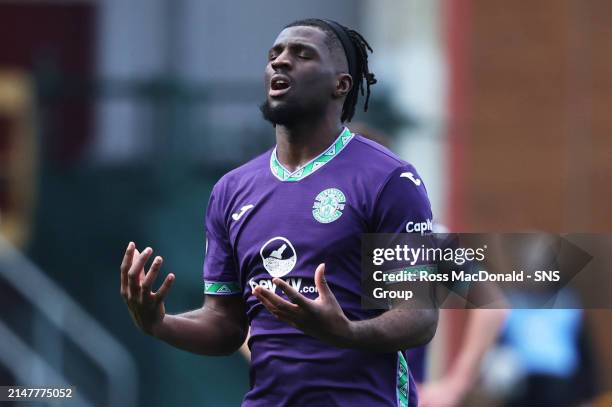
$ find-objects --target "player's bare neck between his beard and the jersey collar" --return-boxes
[276,117,343,171]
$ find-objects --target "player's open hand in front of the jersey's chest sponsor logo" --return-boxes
[253,264,351,347]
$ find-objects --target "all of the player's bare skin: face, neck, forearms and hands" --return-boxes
[121,27,438,355]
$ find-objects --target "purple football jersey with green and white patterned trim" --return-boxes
[204,128,432,407]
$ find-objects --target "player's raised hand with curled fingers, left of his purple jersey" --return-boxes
[121,242,175,335]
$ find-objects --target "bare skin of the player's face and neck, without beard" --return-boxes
[265,27,353,171]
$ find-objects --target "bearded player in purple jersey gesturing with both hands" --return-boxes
[121,19,437,407]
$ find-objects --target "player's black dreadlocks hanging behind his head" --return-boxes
[285,18,376,122]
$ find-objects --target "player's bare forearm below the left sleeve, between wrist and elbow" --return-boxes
[152,304,247,356]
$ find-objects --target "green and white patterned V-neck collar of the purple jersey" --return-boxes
[270,127,354,182]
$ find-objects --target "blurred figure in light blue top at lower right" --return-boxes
[489,309,596,406]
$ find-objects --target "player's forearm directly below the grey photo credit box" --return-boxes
[346,309,438,352]
